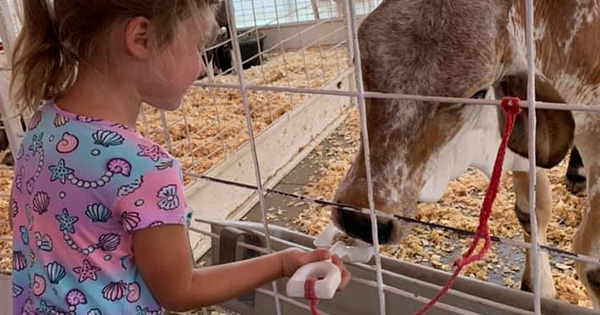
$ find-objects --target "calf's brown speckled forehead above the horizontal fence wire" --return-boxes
[359,0,508,103]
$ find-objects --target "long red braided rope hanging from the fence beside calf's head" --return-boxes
[414,97,521,315]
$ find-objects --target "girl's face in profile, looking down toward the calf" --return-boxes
[142,19,204,110]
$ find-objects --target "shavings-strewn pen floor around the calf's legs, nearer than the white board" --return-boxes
[227,112,591,308]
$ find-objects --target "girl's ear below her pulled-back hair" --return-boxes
[124,16,155,60]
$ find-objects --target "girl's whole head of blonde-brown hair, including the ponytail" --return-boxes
[10,0,218,111]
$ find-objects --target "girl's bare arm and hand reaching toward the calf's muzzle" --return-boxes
[133,225,349,311]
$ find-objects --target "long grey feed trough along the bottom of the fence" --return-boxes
[201,220,598,315]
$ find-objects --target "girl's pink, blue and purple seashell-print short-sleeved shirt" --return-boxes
[11,102,189,315]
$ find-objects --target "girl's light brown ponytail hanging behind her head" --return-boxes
[10,0,77,112]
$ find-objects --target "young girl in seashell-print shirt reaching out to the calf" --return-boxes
[11,0,349,315]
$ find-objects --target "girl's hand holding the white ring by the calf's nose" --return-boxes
[281,248,351,291]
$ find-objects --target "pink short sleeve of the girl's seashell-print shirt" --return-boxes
[115,166,187,233]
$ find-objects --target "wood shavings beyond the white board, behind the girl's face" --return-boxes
[139,47,347,184]
